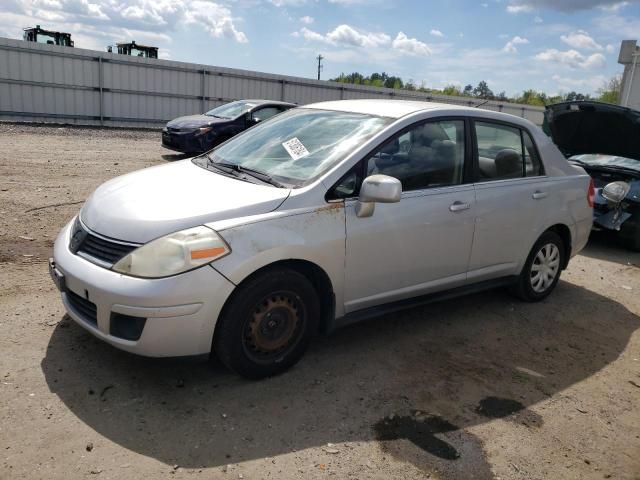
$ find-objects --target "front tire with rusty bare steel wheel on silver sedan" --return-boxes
[213,268,320,379]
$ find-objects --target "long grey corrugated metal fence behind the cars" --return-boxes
[0,37,544,127]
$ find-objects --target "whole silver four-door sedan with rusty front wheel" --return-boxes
[50,100,594,378]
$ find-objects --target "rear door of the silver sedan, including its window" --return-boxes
[468,120,557,282]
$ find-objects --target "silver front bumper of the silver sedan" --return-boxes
[54,222,234,357]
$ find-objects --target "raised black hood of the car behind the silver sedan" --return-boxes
[544,101,640,160]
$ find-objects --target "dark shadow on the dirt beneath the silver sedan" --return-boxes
[41,282,640,479]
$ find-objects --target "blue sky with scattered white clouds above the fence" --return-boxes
[0,0,640,95]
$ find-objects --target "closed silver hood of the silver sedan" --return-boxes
[80,160,290,243]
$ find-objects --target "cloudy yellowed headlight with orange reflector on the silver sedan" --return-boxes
[113,226,231,278]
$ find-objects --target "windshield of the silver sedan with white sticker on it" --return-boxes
[194,108,392,187]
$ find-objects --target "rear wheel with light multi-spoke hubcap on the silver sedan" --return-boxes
[512,231,566,302]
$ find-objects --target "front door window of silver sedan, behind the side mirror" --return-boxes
[367,120,465,191]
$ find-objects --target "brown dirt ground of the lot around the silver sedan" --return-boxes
[0,124,640,480]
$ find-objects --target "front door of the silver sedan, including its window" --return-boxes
[345,120,475,313]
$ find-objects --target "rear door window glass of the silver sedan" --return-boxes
[475,122,542,181]
